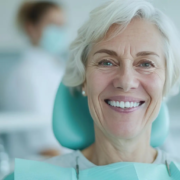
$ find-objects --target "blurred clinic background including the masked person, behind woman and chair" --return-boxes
[0,0,180,179]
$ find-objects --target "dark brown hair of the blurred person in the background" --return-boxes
[17,1,60,29]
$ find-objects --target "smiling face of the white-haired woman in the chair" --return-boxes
[84,18,166,139]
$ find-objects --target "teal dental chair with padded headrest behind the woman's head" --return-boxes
[4,83,169,180]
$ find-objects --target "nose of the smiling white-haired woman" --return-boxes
[113,67,139,92]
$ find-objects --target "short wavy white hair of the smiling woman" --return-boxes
[63,0,180,96]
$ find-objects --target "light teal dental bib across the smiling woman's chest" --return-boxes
[15,159,180,180]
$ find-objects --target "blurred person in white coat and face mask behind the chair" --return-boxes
[2,1,70,159]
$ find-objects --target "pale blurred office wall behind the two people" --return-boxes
[0,0,180,155]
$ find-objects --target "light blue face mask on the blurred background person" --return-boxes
[39,25,67,55]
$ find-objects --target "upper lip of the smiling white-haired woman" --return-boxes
[105,96,145,102]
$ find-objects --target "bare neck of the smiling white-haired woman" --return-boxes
[82,128,157,165]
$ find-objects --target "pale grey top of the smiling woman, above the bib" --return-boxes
[46,148,180,170]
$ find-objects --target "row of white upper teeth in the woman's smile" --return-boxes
[108,101,140,109]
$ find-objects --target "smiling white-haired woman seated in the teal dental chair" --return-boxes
[49,0,180,170]
